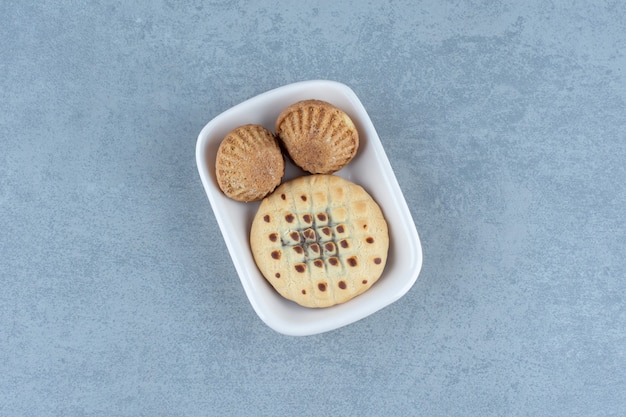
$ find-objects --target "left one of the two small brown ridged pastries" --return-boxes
[215,124,285,202]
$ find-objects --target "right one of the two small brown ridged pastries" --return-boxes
[276,100,359,174]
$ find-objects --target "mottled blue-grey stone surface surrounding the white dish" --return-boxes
[0,0,626,416]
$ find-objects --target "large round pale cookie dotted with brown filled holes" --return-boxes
[250,174,389,308]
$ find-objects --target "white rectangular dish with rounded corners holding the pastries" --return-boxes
[196,80,422,336]
